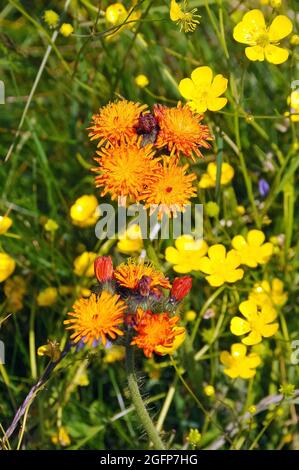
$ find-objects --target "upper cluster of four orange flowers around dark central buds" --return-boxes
[89,100,212,216]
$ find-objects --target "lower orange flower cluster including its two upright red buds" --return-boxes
[64,256,192,357]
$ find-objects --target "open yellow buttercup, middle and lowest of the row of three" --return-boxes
[199,244,244,287]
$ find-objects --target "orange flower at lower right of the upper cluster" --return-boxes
[140,158,196,217]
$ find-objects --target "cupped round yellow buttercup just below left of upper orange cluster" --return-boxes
[70,194,100,227]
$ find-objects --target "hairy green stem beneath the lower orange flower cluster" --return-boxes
[126,344,165,450]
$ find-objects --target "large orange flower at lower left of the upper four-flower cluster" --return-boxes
[93,141,159,199]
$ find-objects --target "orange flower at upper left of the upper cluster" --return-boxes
[88,100,147,147]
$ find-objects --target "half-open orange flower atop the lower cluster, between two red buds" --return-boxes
[114,260,171,296]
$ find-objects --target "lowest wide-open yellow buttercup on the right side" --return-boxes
[220,343,261,379]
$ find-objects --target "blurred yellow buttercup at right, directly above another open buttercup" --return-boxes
[249,278,288,307]
